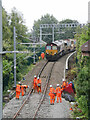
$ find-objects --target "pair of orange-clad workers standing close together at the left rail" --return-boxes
[33,75,41,93]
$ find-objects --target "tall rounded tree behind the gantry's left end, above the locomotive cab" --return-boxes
[34,14,58,43]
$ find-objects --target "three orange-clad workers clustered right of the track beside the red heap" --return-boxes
[48,79,68,105]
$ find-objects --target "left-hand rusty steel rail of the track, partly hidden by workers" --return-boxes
[12,61,48,120]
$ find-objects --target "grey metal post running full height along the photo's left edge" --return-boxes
[0,0,3,120]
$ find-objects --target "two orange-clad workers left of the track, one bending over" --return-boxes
[16,82,29,99]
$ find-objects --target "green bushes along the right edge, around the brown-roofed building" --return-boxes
[75,26,90,118]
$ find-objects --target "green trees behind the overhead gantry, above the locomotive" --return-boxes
[34,14,78,43]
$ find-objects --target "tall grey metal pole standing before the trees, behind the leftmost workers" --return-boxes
[13,27,16,87]
